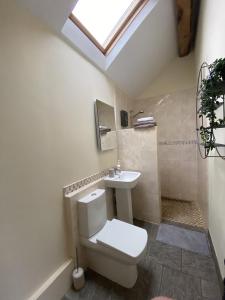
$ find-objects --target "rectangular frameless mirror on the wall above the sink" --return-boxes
[95,100,117,151]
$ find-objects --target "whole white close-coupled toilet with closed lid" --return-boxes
[78,189,148,288]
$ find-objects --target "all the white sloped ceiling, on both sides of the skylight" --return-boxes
[17,0,177,98]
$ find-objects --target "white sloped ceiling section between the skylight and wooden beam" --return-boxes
[107,0,177,97]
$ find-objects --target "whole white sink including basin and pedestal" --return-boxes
[104,171,141,224]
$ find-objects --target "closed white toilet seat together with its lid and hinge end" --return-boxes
[81,219,148,264]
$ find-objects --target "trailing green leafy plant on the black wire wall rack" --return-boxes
[199,58,225,150]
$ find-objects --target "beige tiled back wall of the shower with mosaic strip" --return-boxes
[132,89,197,201]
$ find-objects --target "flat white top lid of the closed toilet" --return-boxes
[96,219,148,258]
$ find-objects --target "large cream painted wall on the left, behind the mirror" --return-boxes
[0,0,126,300]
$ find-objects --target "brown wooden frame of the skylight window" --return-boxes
[69,0,149,55]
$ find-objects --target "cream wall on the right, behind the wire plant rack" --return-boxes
[195,0,225,276]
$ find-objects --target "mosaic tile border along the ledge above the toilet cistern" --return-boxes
[63,169,109,197]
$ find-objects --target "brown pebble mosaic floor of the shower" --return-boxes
[162,198,207,229]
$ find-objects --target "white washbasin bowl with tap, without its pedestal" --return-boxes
[104,171,141,189]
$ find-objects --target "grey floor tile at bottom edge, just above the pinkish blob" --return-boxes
[160,267,201,300]
